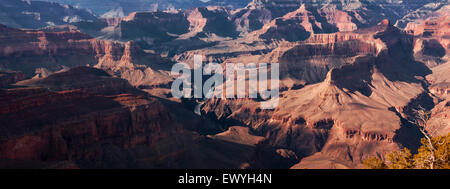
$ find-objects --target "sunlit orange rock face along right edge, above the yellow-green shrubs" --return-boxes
[405,7,450,146]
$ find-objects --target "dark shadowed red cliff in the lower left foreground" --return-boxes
[0,90,181,161]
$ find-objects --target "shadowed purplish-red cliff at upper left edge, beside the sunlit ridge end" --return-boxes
[0,26,106,76]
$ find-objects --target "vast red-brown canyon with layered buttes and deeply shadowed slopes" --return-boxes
[0,0,450,169]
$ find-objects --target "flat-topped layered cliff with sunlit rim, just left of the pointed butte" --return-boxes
[277,34,384,83]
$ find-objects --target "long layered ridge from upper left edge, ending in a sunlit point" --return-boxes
[0,26,172,91]
